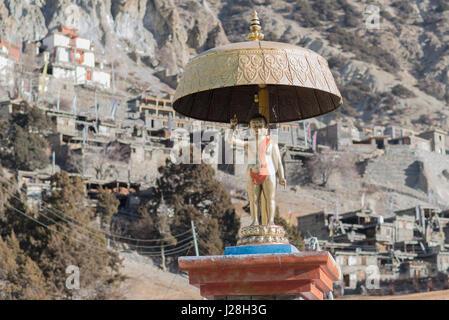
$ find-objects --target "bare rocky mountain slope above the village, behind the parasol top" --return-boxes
[0,0,449,129]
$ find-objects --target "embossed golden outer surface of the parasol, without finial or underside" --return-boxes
[174,41,341,103]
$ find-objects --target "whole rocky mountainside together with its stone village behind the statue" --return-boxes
[0,0,449,298]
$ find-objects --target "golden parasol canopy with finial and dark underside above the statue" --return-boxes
[173,12,342,123]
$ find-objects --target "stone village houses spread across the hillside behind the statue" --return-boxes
[0,21,449,293]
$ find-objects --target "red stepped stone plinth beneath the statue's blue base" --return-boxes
[178,251,339,300]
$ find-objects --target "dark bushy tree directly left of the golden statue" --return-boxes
[130,160,240,268]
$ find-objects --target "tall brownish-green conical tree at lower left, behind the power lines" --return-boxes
[38,172,120,299]
